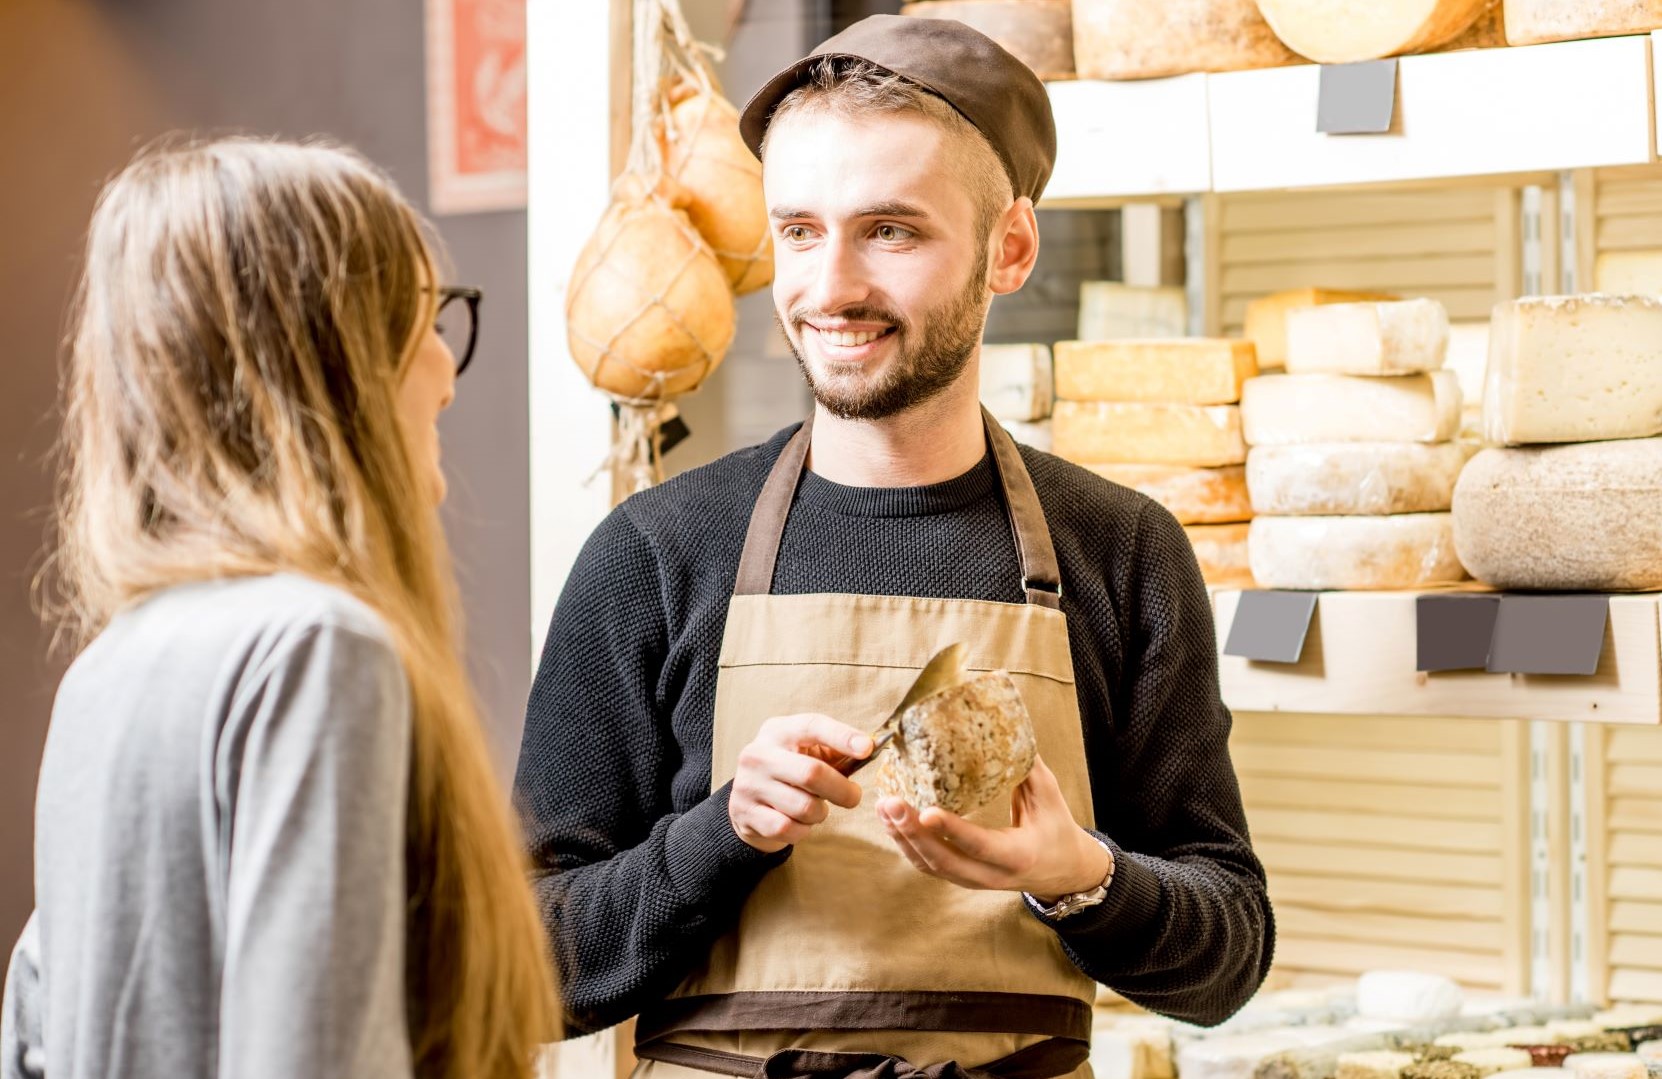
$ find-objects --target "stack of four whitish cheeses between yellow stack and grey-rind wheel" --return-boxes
[1242,299,1471,589]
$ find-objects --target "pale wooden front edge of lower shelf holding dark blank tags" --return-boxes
[1213,589,1662,725]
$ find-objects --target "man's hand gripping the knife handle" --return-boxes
[728,713,871,855]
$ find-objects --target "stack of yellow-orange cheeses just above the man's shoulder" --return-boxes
[1054,337,1258,584]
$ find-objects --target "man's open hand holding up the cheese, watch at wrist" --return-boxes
[878,760,1112,904]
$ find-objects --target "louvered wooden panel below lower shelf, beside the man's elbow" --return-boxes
[1232,713,1529,993]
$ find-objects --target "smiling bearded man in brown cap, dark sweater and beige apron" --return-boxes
[517,15,1273,1079]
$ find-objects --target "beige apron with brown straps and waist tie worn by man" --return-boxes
[635,408,1095,1079]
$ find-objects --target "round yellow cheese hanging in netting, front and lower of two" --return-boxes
[565,176,735,401]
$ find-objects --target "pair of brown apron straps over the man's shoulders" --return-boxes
[733,409,1062,610]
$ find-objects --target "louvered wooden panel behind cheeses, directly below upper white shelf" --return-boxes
[1207,186,1517,336]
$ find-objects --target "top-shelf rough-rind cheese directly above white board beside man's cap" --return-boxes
[1074,0,1298,78]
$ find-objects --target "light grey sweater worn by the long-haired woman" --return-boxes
[0,577,411,1079]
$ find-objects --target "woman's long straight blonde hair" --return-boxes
[48,138,558,1079]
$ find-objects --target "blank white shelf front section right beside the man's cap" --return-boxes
[1040,75,1212,206]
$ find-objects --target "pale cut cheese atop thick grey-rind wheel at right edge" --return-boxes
[1454,294,1662,592]
